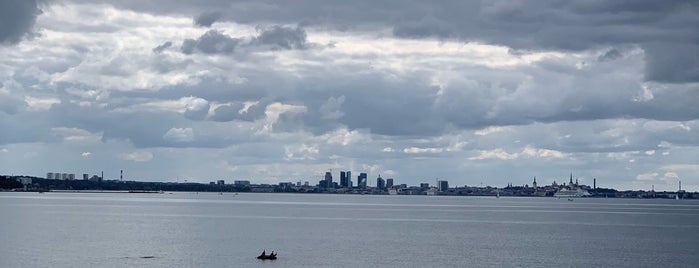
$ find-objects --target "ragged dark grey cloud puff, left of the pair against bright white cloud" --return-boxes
[181,30,241,54]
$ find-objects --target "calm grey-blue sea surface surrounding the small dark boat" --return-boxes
[0,193,699,267]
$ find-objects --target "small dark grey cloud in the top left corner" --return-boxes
[0,0,41,44]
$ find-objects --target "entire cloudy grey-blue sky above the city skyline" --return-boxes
[0,0,699,191]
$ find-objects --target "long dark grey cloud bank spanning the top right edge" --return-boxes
[89,0,699,83]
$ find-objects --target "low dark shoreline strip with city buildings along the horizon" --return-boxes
[0,175,699,199]
